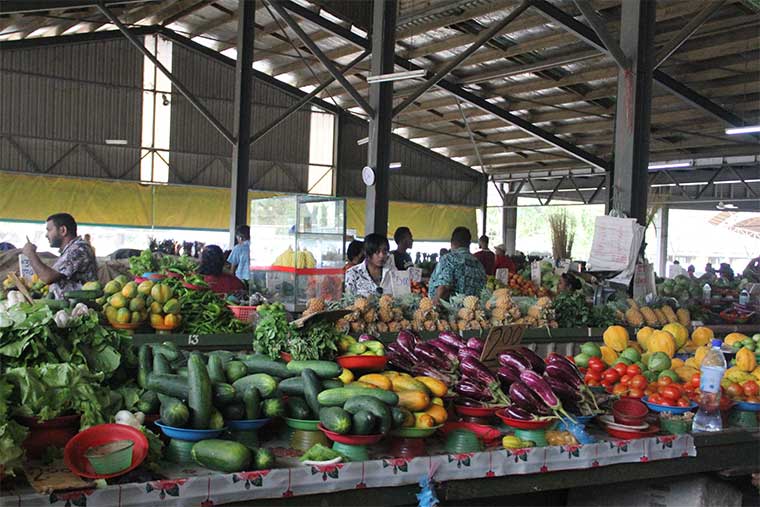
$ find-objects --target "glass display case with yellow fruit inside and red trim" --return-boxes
[250,195,346,312]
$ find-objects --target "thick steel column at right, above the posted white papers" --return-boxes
[611,0,657,225]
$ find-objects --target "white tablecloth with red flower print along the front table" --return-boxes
[0,434,697,507]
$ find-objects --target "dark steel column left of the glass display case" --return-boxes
[230,2,256,245]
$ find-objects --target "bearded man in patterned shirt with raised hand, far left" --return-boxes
[23,213,98,299]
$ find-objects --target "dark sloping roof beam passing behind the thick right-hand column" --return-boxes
[533,0,744,127]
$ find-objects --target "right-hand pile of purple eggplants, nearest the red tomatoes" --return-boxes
[497,347,599,421]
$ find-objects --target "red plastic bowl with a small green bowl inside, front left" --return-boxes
[63,424,148,479]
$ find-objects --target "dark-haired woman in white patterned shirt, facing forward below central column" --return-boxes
[346,233,395,297]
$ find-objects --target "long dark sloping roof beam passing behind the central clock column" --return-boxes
[278,0,609,170]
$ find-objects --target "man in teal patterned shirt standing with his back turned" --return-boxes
[430,227,486,303]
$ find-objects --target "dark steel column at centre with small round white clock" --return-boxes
[364,0,398,236]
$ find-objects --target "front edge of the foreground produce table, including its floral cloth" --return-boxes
[0,430,760,506]
